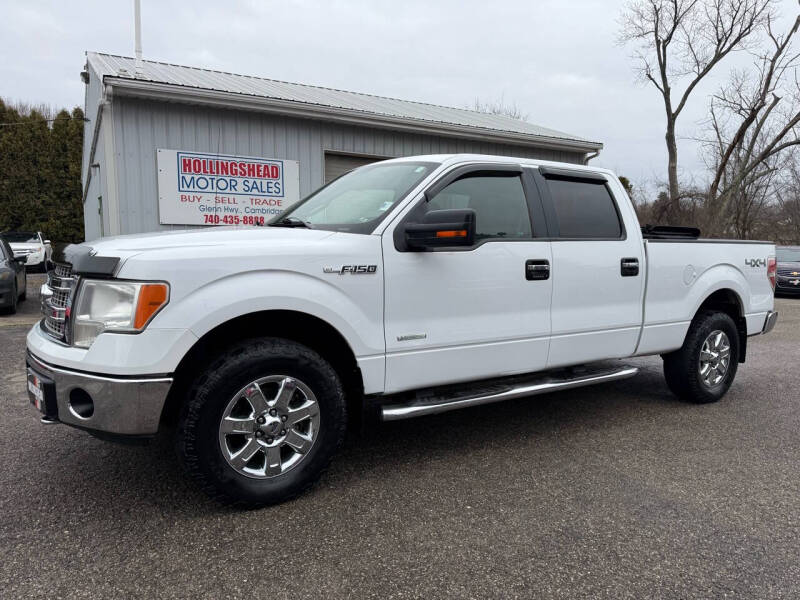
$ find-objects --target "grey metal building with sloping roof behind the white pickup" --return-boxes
[82,52,602,239]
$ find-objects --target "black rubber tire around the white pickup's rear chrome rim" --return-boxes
[664,310,739,404]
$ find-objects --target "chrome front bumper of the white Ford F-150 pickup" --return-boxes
[26,352,172,436]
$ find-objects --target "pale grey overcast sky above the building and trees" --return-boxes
[0,0,797,190]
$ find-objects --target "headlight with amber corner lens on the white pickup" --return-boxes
[72,279,169,348]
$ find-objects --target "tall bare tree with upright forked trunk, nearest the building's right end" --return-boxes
[620,0,774,219]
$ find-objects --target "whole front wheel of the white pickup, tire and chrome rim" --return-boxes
[177,338,347,507]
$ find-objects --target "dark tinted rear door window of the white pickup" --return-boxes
[547,179,622,238]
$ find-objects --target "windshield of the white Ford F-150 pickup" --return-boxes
[270,162,439,233]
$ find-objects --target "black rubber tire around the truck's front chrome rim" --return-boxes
[176,338,347,508]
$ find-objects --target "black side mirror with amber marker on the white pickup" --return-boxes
[405,208,475,251]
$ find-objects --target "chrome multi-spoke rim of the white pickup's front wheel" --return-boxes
[219,375,320,479]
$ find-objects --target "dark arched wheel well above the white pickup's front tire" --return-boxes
[161,310,364,432]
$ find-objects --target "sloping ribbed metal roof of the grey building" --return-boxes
[87,52,603,151]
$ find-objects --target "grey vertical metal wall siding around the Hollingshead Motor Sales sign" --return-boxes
[94,96,584,239]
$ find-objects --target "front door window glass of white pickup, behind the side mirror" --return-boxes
[428,175,532,240]
